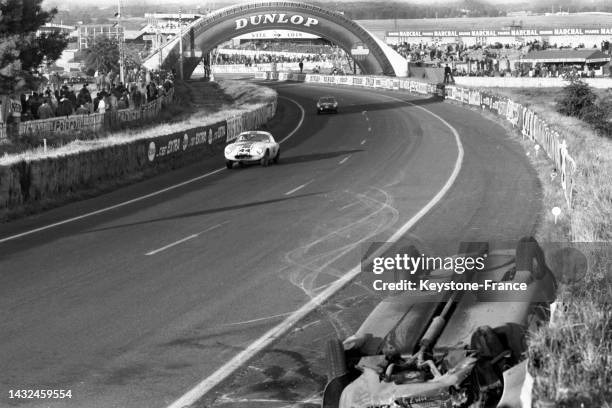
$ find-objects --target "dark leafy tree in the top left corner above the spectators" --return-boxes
[0,0,68,94]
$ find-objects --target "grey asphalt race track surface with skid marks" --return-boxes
[0,83,541,408]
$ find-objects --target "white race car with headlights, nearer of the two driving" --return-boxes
[225,130,280,169]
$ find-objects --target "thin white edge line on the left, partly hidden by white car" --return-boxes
[0,96,306,244]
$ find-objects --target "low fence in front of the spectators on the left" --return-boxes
[14,88,174,140]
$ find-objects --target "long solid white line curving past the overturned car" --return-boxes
[163,91,464,408]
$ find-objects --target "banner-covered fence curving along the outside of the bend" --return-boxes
[270,73,577,208]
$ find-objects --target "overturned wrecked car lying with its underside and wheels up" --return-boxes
[322,238,557,408]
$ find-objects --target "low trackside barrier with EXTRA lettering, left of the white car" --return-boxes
[0,98,277,209]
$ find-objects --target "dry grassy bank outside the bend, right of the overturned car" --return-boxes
[470,88,612,408]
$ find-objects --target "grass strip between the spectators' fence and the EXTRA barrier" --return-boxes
[0,81,276,165]
